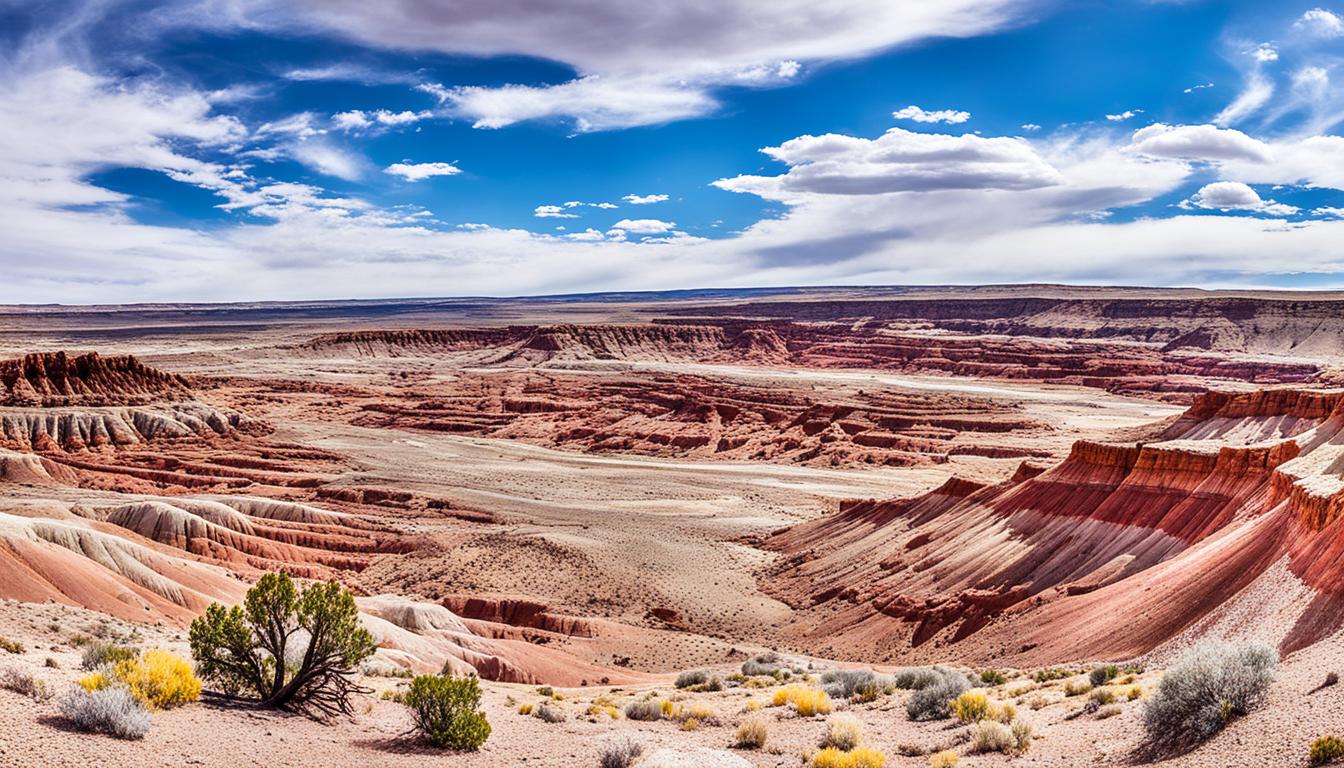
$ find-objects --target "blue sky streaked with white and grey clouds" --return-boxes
[0,0,1344,303]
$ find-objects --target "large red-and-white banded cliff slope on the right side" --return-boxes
[763,390,1344,663]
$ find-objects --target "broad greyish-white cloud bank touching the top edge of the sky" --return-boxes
[231,0,1024,130]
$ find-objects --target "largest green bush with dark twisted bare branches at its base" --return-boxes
[191,573,376,717]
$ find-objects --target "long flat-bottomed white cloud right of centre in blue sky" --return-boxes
[714,128,1060,200]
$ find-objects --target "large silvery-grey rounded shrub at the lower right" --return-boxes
[1144,643,1278,751]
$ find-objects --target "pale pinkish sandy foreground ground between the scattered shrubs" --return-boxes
[0,601,1344,768]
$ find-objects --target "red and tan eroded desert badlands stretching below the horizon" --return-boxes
[0,285,1344,768]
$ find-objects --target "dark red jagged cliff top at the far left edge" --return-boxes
[0,352,191,406]
